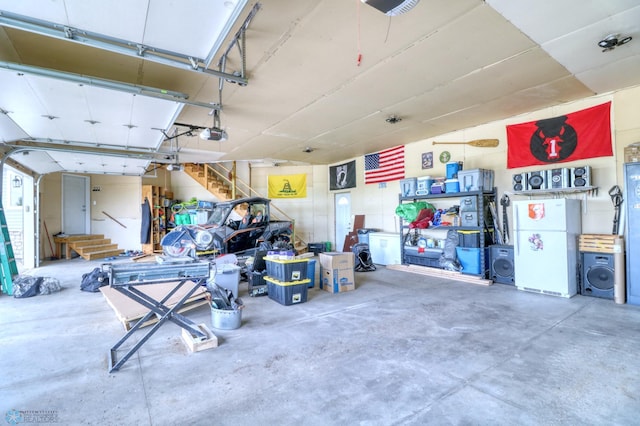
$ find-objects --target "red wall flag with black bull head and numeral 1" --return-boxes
[507,102,613,169]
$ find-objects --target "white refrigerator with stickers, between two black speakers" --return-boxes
[513,198,582,297]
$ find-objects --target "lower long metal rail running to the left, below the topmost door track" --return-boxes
[0,61,220,109]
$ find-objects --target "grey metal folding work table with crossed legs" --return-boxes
[102,261,211,373]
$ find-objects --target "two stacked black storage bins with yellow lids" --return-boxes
[264,251,311,306]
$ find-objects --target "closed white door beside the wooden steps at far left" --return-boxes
[62,175,90,235]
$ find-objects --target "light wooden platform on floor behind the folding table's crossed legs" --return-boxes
[100,281,209,331]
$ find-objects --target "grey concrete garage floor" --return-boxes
[0,258,640,426]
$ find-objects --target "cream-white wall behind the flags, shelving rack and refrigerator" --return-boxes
[252,87,640,247]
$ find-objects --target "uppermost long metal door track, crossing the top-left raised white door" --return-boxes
[0,7,250,85]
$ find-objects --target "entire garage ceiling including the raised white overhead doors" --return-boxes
[0,0,640,174]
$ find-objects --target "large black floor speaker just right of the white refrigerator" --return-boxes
[580,252,615,299]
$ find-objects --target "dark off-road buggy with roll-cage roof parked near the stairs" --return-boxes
[161,197,293,259]
